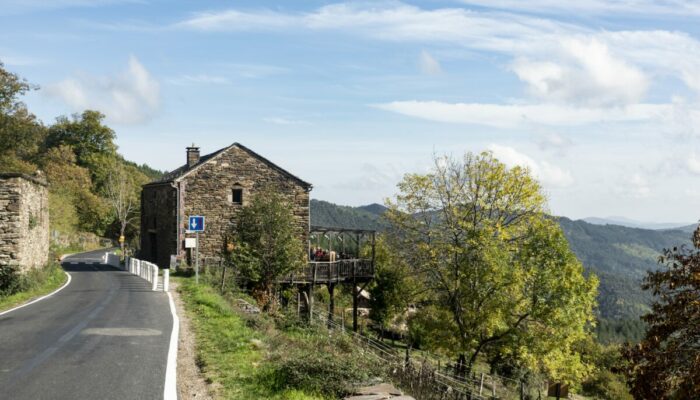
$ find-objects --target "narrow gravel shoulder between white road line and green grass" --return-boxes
[170,281,213,400]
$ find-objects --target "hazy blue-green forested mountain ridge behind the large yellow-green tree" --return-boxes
[311,200,696,320]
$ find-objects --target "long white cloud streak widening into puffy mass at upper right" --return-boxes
[175,0,700,99]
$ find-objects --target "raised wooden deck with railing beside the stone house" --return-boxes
[279,258,374,284]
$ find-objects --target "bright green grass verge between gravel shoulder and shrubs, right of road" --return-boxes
[174,277,323,400]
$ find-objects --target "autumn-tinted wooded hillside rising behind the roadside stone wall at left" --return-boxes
[0,63,161,247]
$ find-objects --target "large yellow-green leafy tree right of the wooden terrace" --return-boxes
[386,153,597,382]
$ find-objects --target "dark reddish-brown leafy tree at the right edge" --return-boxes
[623,229,700,399]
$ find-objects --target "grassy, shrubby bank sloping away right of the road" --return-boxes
[174,277,382,400]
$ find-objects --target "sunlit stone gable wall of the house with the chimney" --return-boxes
[182,146,309,260]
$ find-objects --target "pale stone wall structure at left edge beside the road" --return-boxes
[0,173,49,271]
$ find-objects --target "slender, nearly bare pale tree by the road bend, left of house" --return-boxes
[105,164,138,254]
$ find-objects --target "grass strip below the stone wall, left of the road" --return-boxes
[0,262,68,311]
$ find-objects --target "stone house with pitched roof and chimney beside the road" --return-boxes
[140,143,311,268]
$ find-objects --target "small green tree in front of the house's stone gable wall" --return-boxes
[230,188,305,310]
